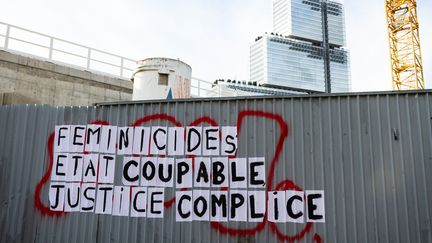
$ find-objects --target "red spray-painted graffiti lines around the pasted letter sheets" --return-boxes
[34,110,322,243]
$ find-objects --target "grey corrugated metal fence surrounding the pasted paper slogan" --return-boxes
[0,91,432,242]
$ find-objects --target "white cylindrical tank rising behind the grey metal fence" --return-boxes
[132,57,192,100]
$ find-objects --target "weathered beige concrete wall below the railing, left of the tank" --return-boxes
[0,50,133,106]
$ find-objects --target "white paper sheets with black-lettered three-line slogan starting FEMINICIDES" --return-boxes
[49,125,325,223]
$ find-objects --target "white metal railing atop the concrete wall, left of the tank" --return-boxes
[0,22,136,79]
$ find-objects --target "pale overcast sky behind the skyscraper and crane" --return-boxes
[0,0,432,91]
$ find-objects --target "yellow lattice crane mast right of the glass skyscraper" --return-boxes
[385,0,424,90]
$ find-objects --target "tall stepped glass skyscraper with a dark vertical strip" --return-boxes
[250,0,351,92]
